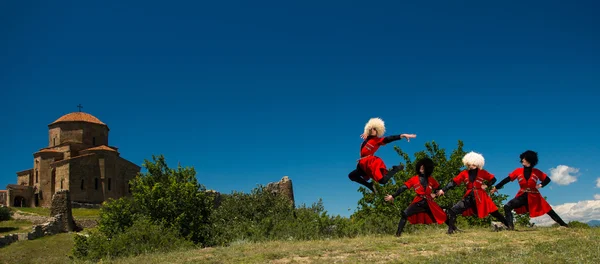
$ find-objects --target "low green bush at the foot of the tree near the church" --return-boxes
[72,217,193,261]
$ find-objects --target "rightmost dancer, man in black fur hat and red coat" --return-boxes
[491,150,568,230]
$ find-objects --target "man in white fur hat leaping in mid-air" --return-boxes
[348,118,417,192]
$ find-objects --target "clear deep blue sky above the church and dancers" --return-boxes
[0,1,600,219]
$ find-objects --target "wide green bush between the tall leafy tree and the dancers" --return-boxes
[212,186,358,245]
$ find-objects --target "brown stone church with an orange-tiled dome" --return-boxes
[4,112,140,207]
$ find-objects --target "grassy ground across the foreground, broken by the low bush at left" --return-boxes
[0,228,600,263]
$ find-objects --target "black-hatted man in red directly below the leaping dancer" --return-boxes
[384,158,446,236]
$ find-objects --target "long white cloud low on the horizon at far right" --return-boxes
[531,201,600,226]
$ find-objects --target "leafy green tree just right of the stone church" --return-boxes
[99,155,218,245]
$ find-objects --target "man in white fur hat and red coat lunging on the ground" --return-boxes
[437,151,508,234]
